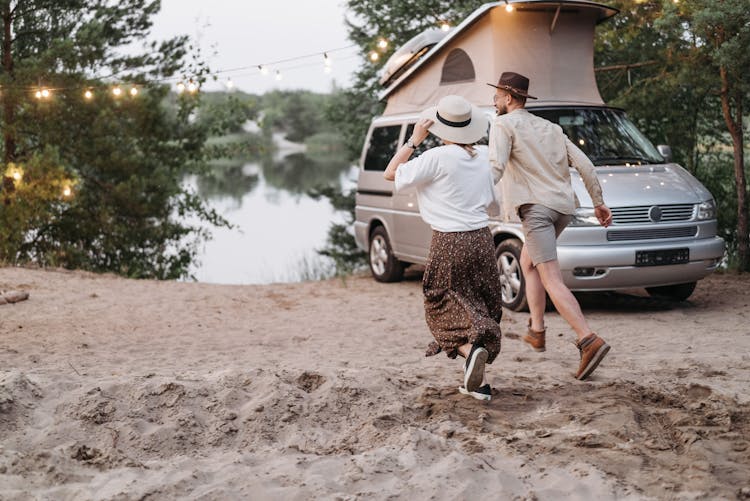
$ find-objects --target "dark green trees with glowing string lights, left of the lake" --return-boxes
[0,0,231,278]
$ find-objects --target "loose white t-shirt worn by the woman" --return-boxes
[396,144,499,233]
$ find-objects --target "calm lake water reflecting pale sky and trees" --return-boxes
[191,131,356,284]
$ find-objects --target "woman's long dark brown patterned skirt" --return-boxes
[422,228,503,363]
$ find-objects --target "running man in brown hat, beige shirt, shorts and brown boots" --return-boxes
[488,72,612,379]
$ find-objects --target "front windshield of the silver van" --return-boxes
[528,108,664,165]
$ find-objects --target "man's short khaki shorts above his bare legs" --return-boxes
[518,204,573,266]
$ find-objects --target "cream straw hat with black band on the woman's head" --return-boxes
[420,95,489,144]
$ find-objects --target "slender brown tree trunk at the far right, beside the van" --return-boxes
[720,66,750,271]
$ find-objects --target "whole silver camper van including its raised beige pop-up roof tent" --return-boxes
[354,0,725,311]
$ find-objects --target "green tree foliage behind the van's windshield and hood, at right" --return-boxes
[596,0,750,268]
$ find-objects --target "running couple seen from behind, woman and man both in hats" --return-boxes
[383,72,612,400]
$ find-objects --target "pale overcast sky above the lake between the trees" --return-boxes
[152,0,363,94]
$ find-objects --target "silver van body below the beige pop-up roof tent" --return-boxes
[354,105,725,311]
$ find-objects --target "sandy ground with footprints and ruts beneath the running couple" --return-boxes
[0,268,750,500]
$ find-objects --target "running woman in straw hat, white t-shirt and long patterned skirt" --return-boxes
[383,96,502,400]
